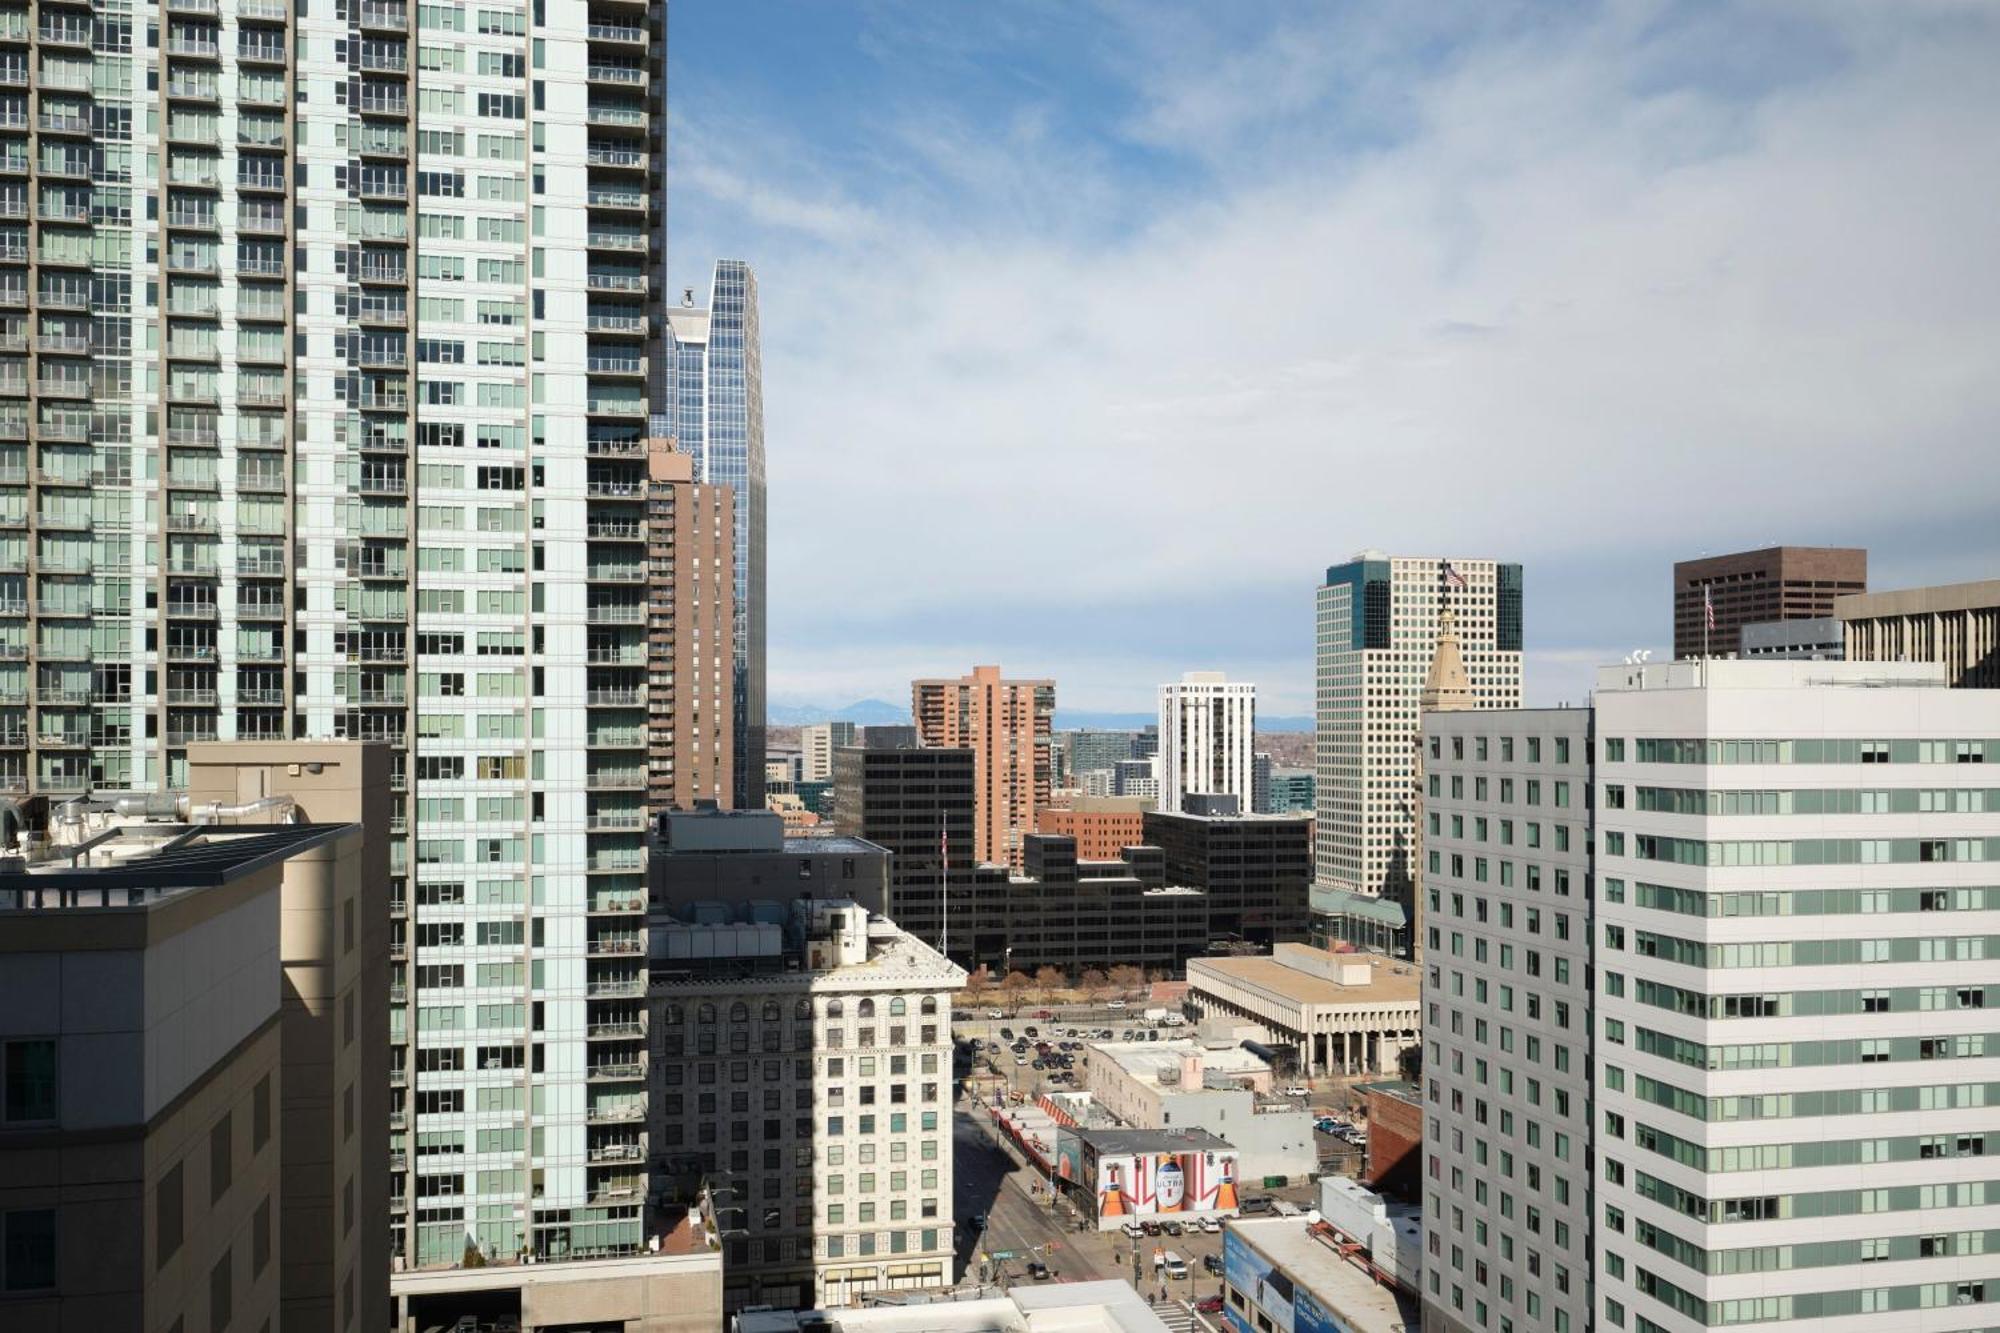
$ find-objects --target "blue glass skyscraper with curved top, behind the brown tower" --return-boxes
[662,260,764,811]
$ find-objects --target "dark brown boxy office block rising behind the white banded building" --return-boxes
[1674,546,1868,660]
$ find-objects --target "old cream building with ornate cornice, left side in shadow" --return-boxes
[650,888,966,1309]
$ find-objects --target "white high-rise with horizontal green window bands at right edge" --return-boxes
[1592,660,2000,1333]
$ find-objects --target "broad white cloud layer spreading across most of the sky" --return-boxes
[674,4,2000,707]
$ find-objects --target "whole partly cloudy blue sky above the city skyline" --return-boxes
[668,0,2000,715]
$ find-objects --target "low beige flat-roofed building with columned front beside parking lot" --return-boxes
[1188,945,1422,1075]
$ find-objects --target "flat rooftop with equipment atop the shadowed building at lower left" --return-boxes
[0,821,356,911]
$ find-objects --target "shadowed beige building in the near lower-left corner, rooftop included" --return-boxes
[0,743,390,1333]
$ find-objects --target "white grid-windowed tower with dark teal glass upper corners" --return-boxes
[1312,550,1522,953]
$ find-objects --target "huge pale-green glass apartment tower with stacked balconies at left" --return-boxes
[0,0,664,1265]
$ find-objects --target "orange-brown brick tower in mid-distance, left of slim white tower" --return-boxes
[910,667,1056,871]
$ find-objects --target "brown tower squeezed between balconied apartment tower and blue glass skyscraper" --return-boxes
[648,440,736,804]
